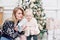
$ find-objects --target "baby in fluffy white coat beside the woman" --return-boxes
[18,9,40,36]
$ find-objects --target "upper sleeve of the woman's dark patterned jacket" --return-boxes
[3,21,14,34]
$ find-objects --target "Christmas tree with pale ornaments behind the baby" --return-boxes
[18,0,46,38]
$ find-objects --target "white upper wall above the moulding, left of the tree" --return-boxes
[0,0,18,7]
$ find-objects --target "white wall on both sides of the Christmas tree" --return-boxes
[0,0,60,20]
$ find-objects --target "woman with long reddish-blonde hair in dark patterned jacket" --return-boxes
[1,7,24,40]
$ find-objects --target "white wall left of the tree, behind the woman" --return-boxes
[0,0,18,21]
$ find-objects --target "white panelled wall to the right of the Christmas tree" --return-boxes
[42,0,60,20]
